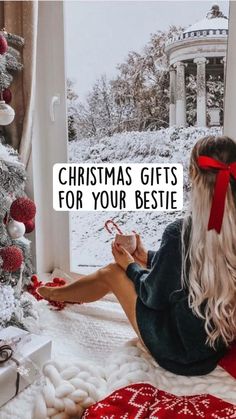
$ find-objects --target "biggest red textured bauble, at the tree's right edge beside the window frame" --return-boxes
[10,197,36,223]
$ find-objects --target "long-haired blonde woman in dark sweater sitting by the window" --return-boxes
[38,136,236,375]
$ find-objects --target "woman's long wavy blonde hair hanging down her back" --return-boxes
[182,136,236,348]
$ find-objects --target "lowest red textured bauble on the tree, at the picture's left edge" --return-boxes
[0,246,23,272]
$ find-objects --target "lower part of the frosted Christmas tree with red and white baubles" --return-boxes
[0,143,36,329]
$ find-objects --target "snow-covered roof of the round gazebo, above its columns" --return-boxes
[183,5,228,34]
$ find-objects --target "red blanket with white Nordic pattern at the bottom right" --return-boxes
[83,344,236,419]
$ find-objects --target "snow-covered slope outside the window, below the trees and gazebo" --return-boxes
[69,127,221,271]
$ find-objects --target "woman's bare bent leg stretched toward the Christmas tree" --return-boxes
[38,263,140,337]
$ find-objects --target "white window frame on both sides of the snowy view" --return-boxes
[31,0,236,274]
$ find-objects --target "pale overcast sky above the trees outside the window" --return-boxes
[65,0,229,100]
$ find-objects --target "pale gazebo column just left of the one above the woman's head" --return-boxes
[175,61,186,127]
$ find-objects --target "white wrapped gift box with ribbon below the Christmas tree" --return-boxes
[0,326,52,406]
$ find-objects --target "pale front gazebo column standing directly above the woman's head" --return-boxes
[194,57,207,127]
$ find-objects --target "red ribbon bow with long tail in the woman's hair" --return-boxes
[197,156,236,234]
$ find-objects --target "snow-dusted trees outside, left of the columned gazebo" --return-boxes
[75,26,182,138]
